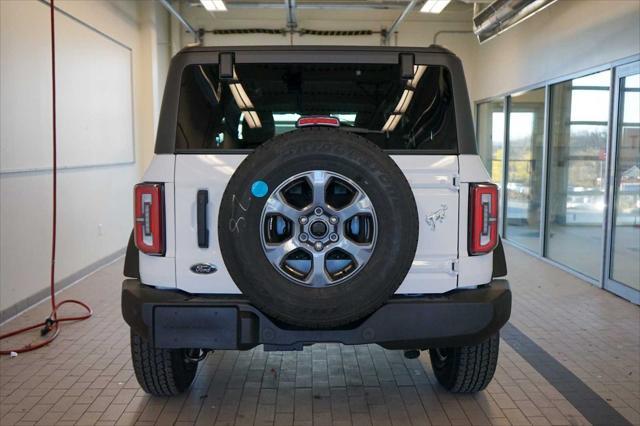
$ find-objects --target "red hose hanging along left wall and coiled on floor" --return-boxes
[0,0,93,355]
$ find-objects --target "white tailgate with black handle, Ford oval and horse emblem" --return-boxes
[175,154,459,294]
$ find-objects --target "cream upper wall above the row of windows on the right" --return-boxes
[472,0,640,100]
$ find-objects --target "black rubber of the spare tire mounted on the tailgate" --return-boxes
[218,128,418,328]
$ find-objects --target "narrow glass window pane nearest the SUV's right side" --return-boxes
[478,100,504,185]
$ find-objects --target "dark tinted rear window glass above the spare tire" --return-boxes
[176,63,457,152]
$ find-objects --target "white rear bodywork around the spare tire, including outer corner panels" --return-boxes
[140,154,493,294]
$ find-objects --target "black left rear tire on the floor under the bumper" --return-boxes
[131,331,198,396]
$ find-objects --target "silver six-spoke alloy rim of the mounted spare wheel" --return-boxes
[260,170,378,288]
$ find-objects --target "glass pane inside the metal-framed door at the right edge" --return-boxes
[611,74,640,290]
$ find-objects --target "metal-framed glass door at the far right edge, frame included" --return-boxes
[604,62,640,304]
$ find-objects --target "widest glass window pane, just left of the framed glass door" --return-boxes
[546,71,611,278]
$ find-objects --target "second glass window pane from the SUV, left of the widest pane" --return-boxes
[505,89,544,252]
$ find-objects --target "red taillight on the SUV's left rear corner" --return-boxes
[133,183,164,256]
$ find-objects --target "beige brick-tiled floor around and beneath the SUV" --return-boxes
[0,243,640,426]
